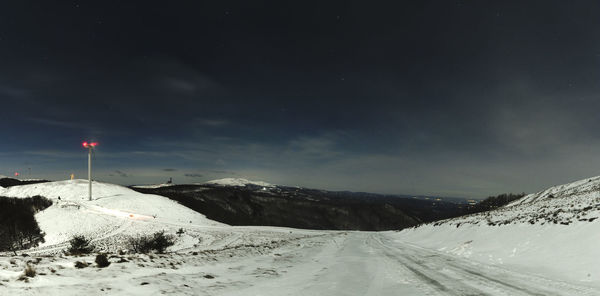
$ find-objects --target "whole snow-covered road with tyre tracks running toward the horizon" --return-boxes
[221,232,600,295]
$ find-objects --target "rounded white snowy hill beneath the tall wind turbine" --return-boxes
[0,180,223,247]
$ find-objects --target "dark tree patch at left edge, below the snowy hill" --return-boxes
[0,195,52,254]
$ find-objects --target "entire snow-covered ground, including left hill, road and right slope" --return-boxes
[0,180,600,296]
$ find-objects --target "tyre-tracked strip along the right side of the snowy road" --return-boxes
[374,236,600,295]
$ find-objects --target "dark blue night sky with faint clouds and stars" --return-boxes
[0,1,600,198]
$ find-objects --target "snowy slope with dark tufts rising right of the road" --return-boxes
[396,177,600,286]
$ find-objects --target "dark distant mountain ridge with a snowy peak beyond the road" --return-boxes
[131,178,466,230]
